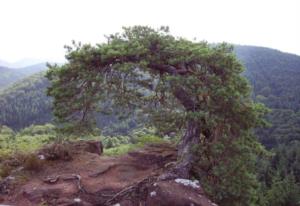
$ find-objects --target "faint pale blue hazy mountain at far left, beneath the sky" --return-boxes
[0,63,47,90]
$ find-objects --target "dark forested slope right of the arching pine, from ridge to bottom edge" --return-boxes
[235,46,300,206]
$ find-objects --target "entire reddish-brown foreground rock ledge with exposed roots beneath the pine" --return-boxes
[0,141,215,206]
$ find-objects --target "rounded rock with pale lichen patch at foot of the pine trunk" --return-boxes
[146,180,216,206]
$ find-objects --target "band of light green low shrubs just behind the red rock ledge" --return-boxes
[0,124,170,178]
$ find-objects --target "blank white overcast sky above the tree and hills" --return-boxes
[0,0,300,61]
